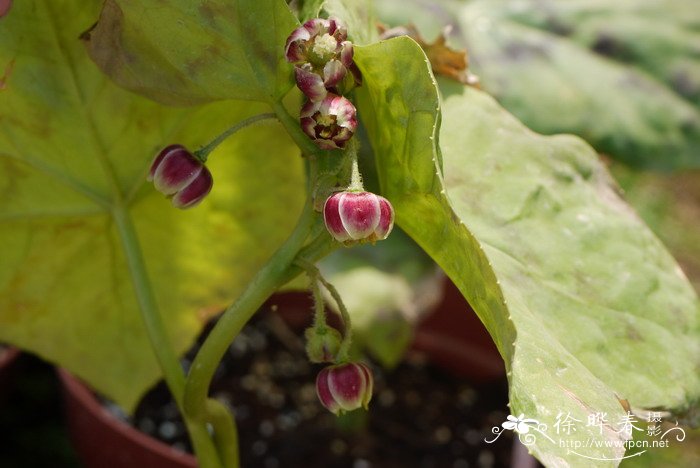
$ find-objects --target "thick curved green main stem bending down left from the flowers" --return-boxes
[184,200,314,420]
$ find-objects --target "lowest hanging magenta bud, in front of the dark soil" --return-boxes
[316,362,374,416]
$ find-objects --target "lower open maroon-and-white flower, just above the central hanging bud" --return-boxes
[300,93,357,150]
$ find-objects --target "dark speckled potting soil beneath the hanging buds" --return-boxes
[113,302,512,468]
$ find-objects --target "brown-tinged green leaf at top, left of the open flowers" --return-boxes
[85,0,298,104]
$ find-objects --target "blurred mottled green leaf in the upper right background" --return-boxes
[379,0,700,169]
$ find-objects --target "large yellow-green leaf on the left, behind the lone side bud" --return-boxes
[0,0,303,408]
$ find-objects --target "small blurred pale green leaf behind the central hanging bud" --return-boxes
[319,230,445,368]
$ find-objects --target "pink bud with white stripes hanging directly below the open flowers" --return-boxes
[323,192,394,244]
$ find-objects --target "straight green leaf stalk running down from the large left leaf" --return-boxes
[112,201,221,468]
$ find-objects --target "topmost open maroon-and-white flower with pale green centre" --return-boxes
[285,18,360,101]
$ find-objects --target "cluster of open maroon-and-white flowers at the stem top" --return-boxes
[285,18,360,150]
